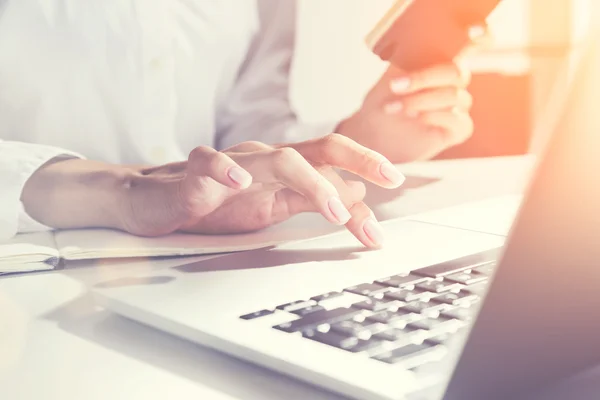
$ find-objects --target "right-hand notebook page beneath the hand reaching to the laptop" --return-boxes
[55,229,290,260]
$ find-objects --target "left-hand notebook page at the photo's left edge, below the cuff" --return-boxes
[0,232,59,273]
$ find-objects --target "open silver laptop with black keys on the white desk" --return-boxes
[94,27,600,400]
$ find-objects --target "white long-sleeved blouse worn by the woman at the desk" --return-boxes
[0,0,334,240]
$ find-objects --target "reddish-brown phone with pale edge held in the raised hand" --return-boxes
[366,0,502,71]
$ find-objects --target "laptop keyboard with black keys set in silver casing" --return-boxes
[240,249,500,369]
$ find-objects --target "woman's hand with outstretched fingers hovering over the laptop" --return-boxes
[23,134,404,247]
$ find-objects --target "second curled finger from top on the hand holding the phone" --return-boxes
[384,86,473,117]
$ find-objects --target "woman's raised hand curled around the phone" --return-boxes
[337,64,473,163]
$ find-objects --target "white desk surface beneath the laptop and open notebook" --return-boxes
[5,158,598,400]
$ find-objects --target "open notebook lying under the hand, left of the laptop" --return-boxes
[0,229,285,274]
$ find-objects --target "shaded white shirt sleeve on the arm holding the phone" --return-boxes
[216,0,338,149]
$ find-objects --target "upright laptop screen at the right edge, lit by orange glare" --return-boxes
[444,14,600,400]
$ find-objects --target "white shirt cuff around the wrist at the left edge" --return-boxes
[0,139,81,242]
